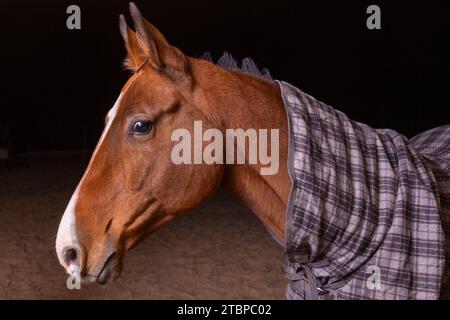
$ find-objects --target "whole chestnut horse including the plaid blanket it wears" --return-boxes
[56,3,450,299]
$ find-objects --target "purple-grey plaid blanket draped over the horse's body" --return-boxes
[278,82,450,299]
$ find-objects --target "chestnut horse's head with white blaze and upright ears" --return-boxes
[56,3,223,283]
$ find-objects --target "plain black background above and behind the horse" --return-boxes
[0,0,450,151]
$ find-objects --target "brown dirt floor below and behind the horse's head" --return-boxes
[0,156,286,299]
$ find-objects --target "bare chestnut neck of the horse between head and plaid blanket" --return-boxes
[193,58,291,241]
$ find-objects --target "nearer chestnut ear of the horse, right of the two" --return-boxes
[128,2,188,75]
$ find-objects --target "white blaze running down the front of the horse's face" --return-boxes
[55,94,122,274]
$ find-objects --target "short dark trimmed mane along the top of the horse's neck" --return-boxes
[199,51,273,81]
